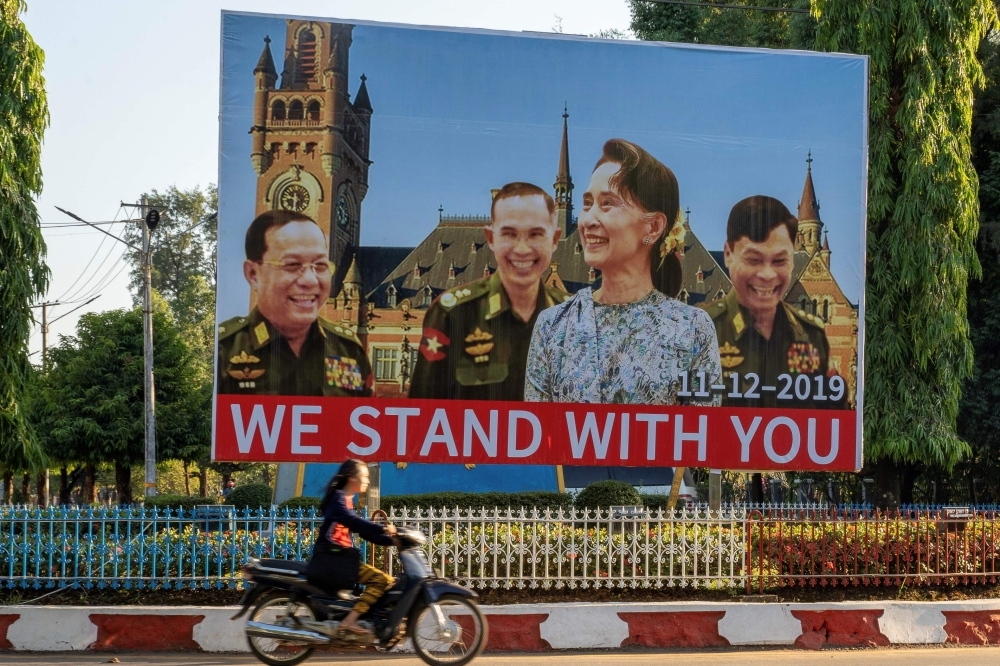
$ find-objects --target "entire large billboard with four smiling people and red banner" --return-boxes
[213,12,868,476]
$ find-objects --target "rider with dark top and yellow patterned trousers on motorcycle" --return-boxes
[306,459,396,636]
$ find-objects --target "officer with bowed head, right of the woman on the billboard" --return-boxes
[703,195,846,409]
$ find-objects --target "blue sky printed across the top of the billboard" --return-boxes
[218,14,866,319]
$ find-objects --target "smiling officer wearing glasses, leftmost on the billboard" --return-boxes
[218,211,372,396]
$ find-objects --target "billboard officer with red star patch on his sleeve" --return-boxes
[409,183,569,400]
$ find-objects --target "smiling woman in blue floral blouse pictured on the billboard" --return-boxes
[524,139,722,405]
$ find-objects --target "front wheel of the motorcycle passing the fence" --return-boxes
[408,594,490,666]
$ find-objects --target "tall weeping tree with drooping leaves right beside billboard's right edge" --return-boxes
[814,0,996,503]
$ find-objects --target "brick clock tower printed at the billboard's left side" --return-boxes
[250,20,372,296]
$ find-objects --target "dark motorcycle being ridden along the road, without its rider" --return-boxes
[232,527,489,666]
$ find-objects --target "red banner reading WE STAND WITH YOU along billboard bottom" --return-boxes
[213,394,861,472]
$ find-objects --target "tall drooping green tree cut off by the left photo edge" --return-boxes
[0,0,49,478]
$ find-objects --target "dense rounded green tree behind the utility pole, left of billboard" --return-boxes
[43,298,211,504]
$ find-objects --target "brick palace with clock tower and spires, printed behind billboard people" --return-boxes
[250,20,858,404]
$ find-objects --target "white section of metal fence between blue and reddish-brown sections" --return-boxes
[378,507,746,589]
